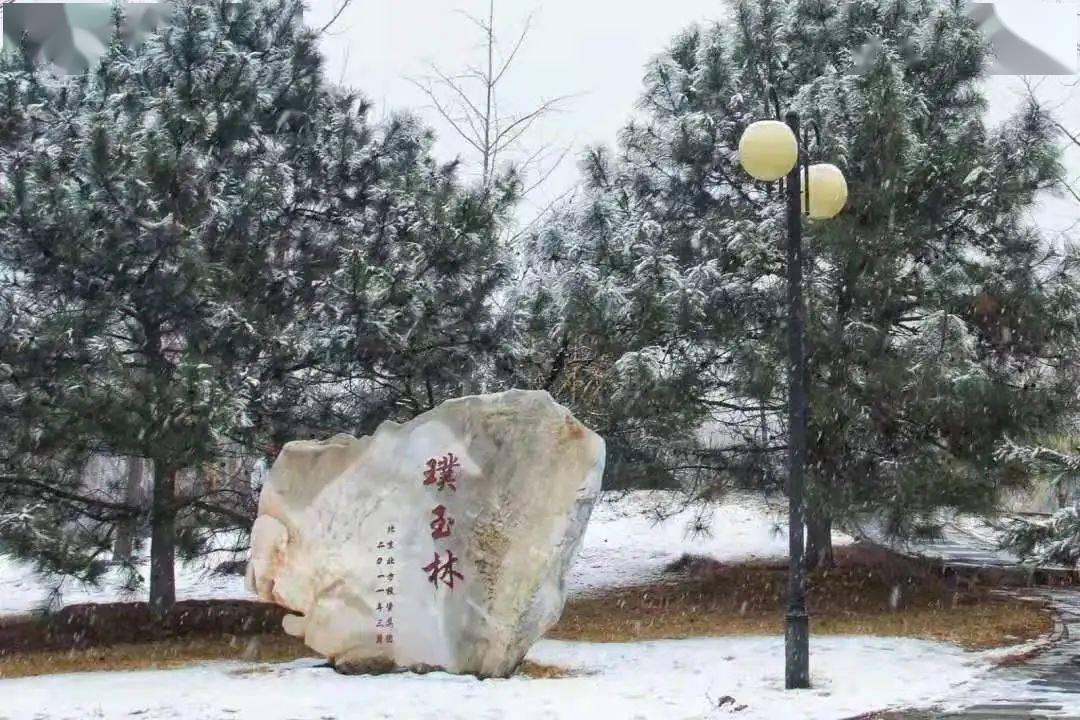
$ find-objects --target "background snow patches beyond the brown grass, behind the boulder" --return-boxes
[0,492,848,615]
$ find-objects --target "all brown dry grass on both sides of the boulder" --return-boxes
[0,546,1051,679]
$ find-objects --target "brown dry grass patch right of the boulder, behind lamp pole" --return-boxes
[549,547,1051,649]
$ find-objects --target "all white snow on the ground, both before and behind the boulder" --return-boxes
[0,493,1032,720]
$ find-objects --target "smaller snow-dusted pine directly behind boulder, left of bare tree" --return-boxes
[291,103,518,433]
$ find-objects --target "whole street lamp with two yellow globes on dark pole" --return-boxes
[739,98,848,690]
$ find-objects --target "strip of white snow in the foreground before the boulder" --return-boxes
[0,637,988,720]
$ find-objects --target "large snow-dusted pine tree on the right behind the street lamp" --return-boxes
[508,0,1080,562]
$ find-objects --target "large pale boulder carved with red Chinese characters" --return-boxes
[247,391,605,677]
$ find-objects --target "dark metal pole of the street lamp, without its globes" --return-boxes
[784,112,810,690]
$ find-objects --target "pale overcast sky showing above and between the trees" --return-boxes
[308,0,1080,231]
